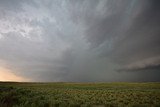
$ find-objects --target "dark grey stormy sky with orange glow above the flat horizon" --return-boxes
[0,0,160,82]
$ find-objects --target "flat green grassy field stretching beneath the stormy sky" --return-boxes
[0,82,160,107]
